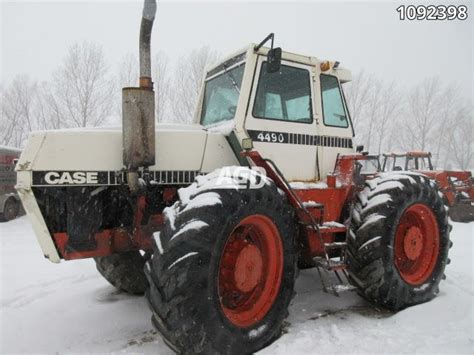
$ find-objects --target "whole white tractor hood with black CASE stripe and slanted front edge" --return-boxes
[16,125,238,262]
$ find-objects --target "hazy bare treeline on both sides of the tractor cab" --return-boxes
[0,42,474,169]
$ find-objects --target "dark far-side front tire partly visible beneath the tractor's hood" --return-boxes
[94,250,148,295]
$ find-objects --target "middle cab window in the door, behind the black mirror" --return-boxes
[252,62,313,123]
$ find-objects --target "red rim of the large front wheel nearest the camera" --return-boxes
[218,215,283,328]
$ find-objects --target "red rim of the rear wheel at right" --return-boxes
[395,203,439,285]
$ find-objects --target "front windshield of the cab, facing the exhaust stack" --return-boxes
[201,63,245,126]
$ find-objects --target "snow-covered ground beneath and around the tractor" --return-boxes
[0,217,474,355]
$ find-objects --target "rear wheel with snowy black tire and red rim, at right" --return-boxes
[347,172,452,311]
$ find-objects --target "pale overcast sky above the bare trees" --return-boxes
[0,0,474,97]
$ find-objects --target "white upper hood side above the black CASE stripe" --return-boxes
[17,125,226,171]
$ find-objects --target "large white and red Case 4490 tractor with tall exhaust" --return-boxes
[13,1,452,354]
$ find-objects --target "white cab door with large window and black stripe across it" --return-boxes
[244,56,319,181]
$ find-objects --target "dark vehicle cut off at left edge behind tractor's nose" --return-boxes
[0,146,22,222]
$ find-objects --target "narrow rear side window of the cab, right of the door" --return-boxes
[320,74,349,128]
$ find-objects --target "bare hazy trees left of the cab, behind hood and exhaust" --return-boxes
[0,42,219,147]
